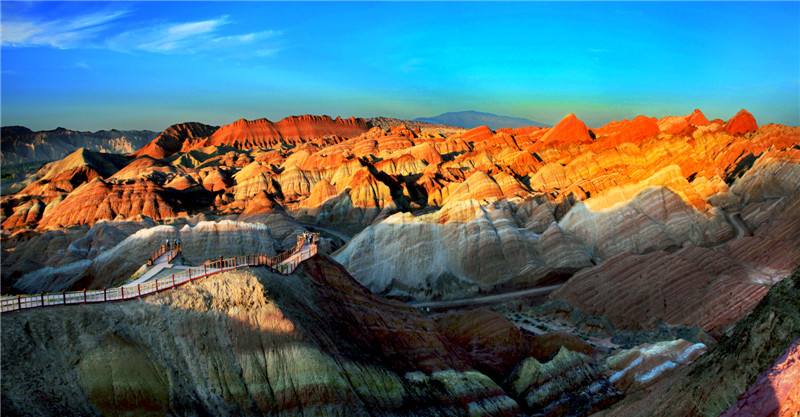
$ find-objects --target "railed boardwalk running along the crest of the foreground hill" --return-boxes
[0,231,318,313]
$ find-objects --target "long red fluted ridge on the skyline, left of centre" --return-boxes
[208,115,369,148]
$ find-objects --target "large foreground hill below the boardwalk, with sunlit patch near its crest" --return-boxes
[2,259,519,416]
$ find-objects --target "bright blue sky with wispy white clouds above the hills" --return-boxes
[0,1,800,130]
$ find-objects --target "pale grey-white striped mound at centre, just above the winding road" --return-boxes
[336,199,590,298]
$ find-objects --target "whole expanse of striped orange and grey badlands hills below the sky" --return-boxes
[2,110,800,416]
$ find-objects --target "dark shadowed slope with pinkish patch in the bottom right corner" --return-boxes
[602,270,800,417]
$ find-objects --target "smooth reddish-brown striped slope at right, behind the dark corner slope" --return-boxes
[552,152,800,334]
